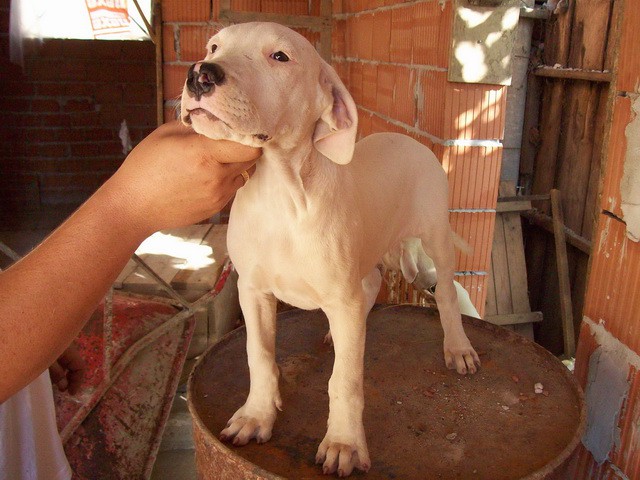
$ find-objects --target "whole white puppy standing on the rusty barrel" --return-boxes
[181,23,479,476]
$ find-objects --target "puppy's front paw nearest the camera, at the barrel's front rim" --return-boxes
[316,433,371,477]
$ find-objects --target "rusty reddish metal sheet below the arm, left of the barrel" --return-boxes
[55,294,195,480]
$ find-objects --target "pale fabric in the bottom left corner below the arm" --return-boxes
[0,371,71,480]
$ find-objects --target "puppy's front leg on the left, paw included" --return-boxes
[220,284,282,445]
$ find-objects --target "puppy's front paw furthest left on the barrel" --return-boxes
[220,405,276,446]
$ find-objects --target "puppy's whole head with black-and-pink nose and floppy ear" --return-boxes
[181,23,357,164]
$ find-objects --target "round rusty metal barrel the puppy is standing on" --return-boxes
[188,306,586,480]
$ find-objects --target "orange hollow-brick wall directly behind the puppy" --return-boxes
[163,0,506,313]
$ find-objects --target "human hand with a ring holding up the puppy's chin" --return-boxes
[103,122,261,234]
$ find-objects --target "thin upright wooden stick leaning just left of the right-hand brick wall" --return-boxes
[551,189,576,357]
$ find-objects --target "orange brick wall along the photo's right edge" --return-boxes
[571,2,640,480]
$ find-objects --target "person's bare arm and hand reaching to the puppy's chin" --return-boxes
[0,122,260,403]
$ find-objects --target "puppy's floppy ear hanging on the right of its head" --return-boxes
[313,60,358,165]
